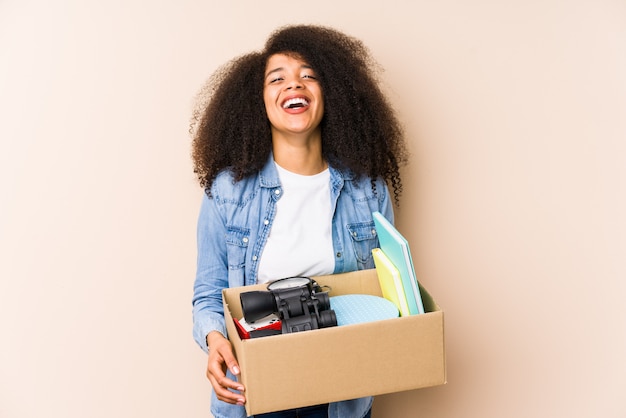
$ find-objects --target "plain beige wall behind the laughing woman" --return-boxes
[0,0,626,418]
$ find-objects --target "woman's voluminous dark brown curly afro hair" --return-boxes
[190,25,408,204]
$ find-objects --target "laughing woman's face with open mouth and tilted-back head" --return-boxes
[263,54,324,142]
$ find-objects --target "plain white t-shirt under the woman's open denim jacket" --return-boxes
[257,164,335,283]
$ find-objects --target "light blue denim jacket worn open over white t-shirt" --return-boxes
[193,156,393,418]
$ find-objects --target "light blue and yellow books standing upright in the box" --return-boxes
[372,212,424,316]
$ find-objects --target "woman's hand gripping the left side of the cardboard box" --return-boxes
[206,331,246,405]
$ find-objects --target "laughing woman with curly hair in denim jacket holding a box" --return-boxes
[192,25,407,418]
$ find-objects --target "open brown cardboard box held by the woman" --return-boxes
[222,269,446,415]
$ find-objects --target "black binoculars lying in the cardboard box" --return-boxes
[239,277,337,334]
